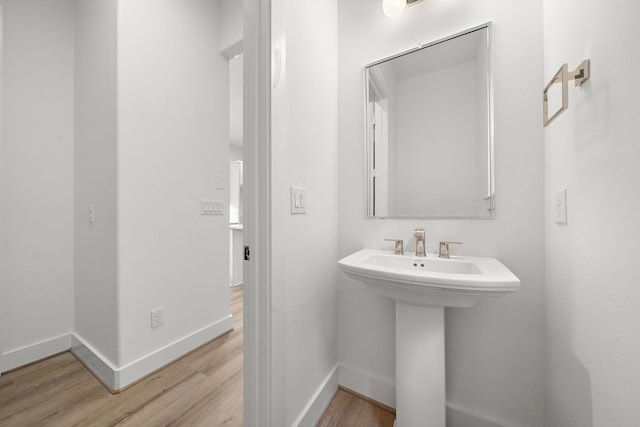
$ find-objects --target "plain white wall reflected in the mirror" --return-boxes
[390,61,486,216]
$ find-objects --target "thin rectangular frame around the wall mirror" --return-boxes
[362,21,496,219]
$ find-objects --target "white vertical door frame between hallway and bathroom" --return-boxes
[243,0,272,427]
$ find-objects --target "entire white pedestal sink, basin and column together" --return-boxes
[338,249,520,427]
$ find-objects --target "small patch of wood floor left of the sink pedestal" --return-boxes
[317,388,396,427]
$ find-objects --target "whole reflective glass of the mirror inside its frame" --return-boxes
[365,24,495,218]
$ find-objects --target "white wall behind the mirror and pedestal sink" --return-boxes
[338,0,544,426]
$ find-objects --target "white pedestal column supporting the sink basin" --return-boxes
[395,301,446,427]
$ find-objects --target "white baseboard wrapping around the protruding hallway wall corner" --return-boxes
[71,315,233,392]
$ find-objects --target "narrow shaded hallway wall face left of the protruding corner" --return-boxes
[73,0,119,366]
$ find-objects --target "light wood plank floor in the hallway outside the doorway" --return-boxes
[0,286,243,427]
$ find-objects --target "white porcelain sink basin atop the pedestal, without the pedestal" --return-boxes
[338,249,520,307]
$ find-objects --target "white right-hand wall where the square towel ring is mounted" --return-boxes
[540,0,640,427]
